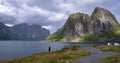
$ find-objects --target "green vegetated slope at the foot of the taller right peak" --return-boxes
[80,29,120,42]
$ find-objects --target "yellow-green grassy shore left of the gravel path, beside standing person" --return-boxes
[0,46,88,63]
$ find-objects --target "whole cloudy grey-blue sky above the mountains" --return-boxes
[0,0,120,33]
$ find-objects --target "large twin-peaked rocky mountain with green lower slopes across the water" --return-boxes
[46,7,120,42]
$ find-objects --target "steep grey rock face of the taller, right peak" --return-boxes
[89,7,118,35]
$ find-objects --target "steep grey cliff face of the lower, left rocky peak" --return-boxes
[63,13,90,41]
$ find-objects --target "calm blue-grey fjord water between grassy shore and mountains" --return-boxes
[0,41,105,60]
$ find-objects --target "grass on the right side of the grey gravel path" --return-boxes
[97,46,120,63]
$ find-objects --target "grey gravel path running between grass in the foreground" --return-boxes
[78,47,119,63]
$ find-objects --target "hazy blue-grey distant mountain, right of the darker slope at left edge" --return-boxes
[10,23,50,40]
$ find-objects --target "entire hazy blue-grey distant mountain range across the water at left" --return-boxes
[0,22,50,41]
